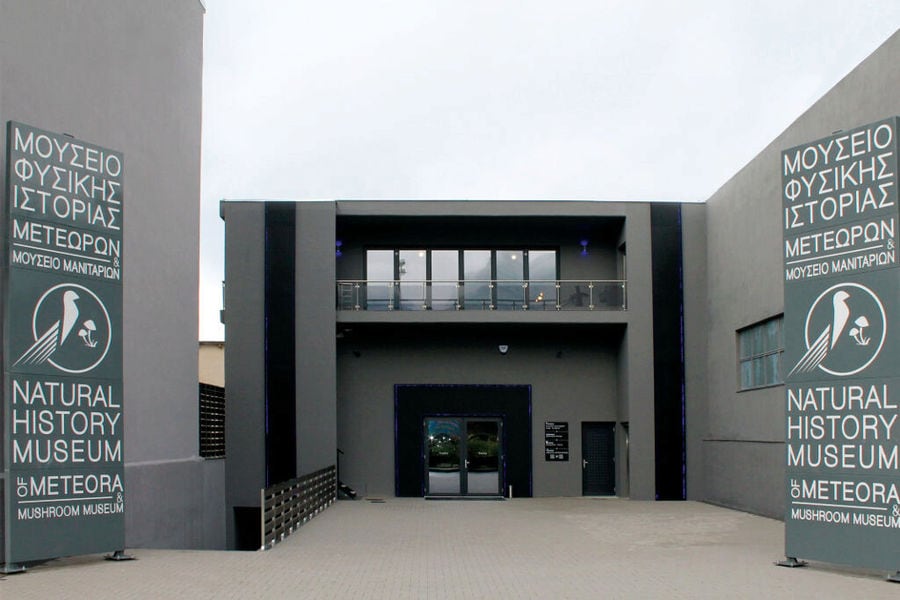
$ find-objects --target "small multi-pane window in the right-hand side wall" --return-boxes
[737,315,784,390]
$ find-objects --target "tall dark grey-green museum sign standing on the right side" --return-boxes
[781,118,900,570]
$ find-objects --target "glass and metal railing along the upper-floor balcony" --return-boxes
[337,279,628,311]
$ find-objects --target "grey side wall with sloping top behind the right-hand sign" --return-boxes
[704,33,900,517]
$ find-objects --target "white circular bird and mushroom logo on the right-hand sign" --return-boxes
[788,283,887,377]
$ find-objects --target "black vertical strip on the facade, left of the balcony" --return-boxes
[265,203,297,486]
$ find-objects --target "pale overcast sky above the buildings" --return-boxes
[199,0,900,340]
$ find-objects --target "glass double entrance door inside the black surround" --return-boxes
[424,417,503,496]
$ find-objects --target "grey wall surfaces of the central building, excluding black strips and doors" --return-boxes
[223,201,655,506]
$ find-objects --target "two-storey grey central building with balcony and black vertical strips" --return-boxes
[222,201,684,548]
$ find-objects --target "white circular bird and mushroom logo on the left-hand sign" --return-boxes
[13,283,112,374]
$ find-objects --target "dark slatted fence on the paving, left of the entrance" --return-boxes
[260,465,337,550]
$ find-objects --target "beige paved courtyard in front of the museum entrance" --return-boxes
[0,498,900,600]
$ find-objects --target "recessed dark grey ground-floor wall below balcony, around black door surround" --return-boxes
[338,325,623,496]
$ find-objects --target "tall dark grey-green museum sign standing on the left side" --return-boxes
[3,122,125,564]
